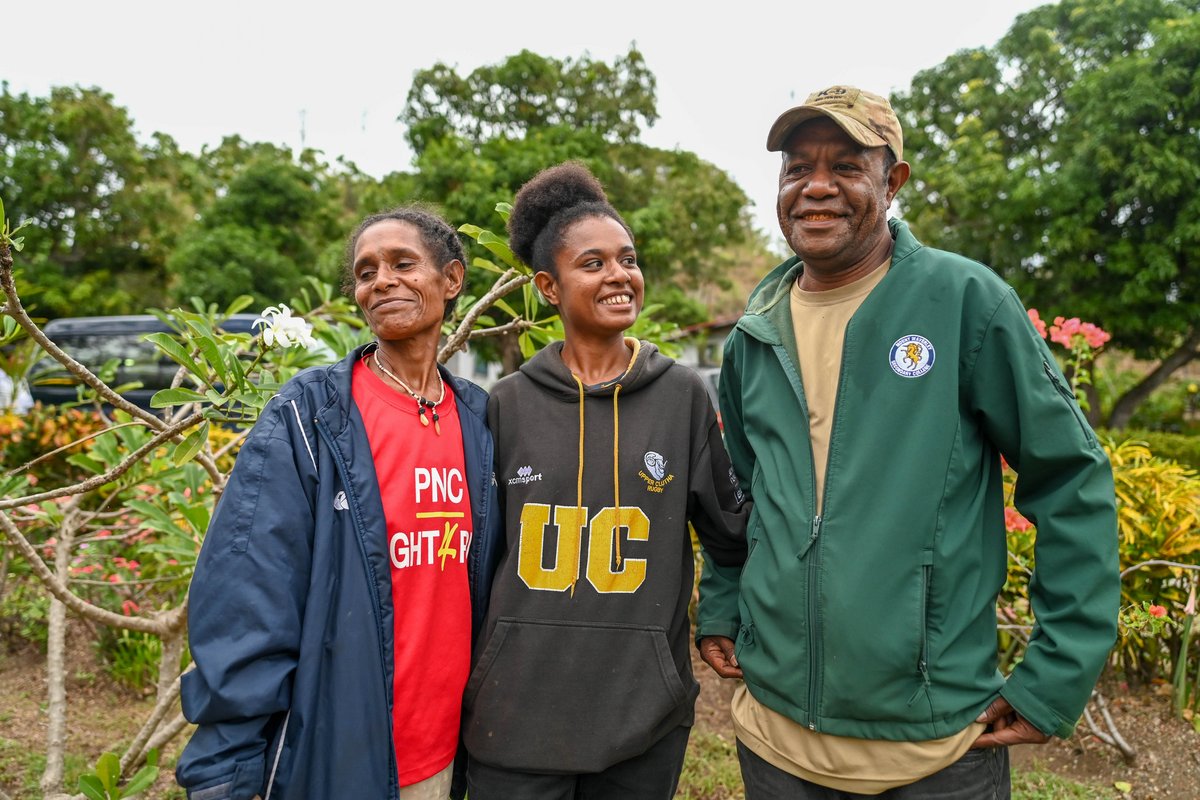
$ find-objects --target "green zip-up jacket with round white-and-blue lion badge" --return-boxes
[697,219,1120,741]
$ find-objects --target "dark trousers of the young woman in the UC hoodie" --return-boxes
[467,728,691,800]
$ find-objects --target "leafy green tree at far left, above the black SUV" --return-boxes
[0,83,196,317]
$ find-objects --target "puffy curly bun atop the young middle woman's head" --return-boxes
[508,161,624,267]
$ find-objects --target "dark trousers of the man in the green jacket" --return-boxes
[738,741,1012,800]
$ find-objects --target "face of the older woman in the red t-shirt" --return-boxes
[352,219,463,341]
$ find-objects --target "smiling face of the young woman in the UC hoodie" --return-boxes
[534,216,644,337]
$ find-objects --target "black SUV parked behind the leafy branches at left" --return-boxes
[29,314,258,410]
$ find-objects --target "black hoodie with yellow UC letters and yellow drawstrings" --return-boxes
[463,339,749,772]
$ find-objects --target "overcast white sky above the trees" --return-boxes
[7,0,1043,242]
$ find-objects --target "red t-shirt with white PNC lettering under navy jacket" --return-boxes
[353,361,473,786]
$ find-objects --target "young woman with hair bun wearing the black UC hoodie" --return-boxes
[463,163,749,800]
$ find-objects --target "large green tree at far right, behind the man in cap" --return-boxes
[894,0,1200,427]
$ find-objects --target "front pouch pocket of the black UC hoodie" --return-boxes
[463,616,698,772]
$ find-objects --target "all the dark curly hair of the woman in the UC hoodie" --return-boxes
[509,161,634,277]
